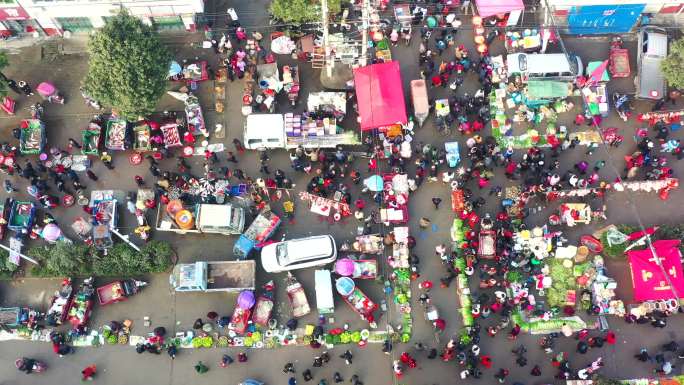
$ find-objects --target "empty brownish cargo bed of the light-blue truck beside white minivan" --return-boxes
[207,261,256,290]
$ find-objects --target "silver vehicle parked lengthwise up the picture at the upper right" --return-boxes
[634,25,667,100]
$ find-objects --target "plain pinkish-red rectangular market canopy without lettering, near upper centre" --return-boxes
[354,61,406,131]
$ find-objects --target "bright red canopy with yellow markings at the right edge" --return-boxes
[627,240,684,302]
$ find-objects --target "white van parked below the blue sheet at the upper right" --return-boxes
[506,53,584,82]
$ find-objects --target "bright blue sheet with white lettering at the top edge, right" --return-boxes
[568,4,646,35]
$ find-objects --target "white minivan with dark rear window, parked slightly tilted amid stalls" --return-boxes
[261,235,337,273]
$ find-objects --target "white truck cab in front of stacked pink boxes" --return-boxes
[243,114,286,150]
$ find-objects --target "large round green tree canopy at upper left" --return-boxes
[83,11,171,119]
